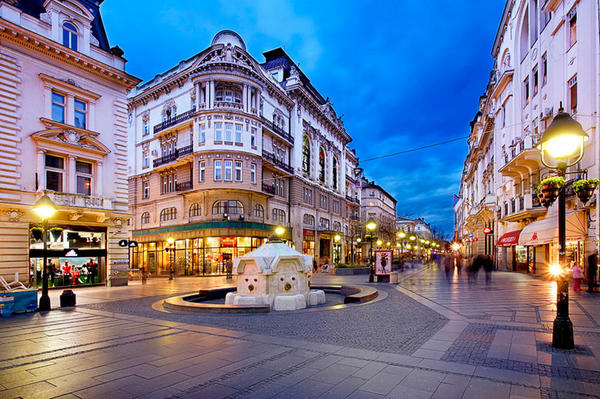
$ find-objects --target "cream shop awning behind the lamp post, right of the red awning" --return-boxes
[519,212,587,245]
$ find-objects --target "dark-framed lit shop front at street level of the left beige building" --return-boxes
[29,225,107,288]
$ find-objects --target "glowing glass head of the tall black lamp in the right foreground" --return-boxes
[537,108,589,168]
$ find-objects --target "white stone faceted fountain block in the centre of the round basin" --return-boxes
[225,240,325,310]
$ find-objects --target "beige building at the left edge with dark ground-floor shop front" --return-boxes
[0,0,139,286]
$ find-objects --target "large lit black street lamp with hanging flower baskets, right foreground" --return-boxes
[537,103,588,349]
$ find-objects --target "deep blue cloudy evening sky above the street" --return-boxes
[101,0,505,235]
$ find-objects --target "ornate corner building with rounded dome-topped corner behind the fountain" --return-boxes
[128,30,360,275]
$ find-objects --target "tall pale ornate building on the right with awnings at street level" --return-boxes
[455,0,600,273]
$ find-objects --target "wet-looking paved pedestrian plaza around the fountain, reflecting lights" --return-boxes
[0,265,600,399]
